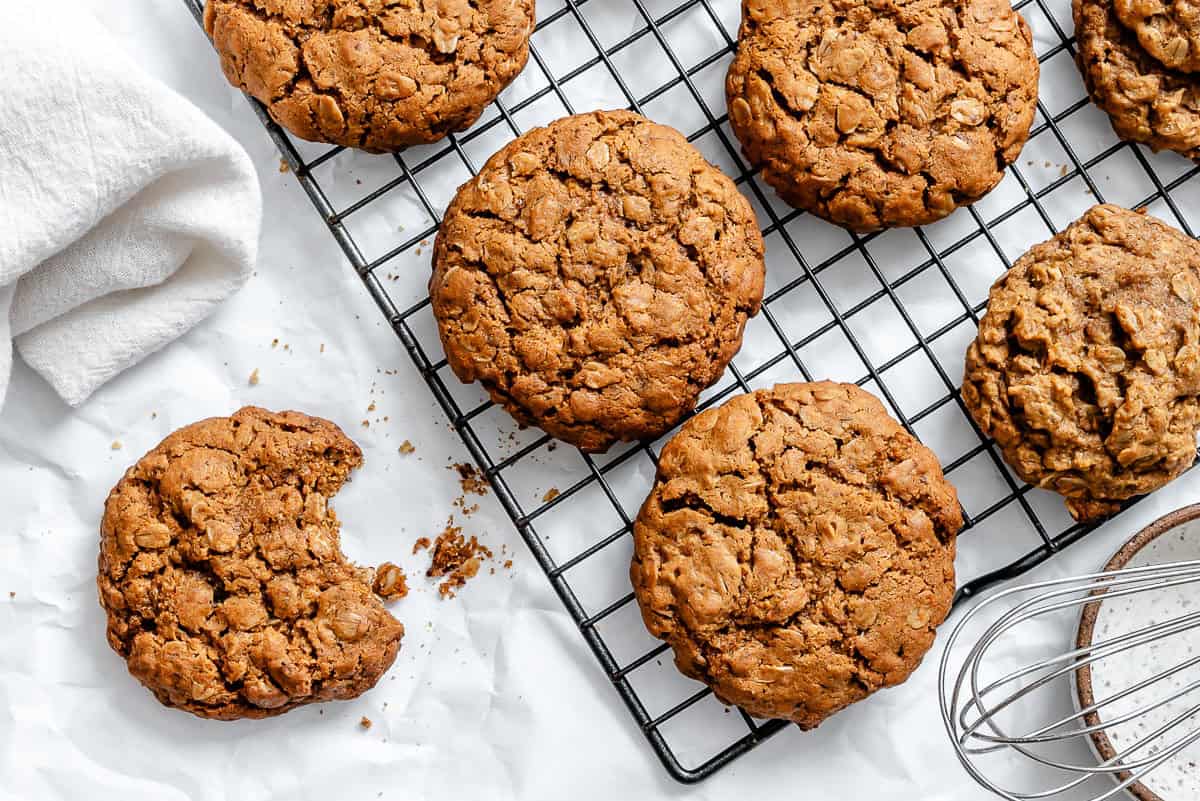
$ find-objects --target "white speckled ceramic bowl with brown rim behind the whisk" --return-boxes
[1075,504,1200,801]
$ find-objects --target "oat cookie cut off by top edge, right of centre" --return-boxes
[726,0,1038,231]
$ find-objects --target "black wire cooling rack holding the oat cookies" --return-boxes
[185,0,1200,782]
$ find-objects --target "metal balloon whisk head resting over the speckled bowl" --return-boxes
[938,561,1200,801]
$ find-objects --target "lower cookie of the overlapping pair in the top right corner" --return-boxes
[1074,0,1200,159]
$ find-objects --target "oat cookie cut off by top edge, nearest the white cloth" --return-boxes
[204,0,534,152]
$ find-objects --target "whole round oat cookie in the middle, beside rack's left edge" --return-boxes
[430,112,764,451]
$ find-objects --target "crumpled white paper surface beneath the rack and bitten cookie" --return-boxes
[0,0,1200,801]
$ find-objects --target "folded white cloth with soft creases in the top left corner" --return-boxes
[0,0,262,405]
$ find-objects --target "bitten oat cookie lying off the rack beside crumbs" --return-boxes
[97,406,404,721]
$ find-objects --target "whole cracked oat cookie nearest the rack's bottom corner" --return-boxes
[630,381,962,728]
